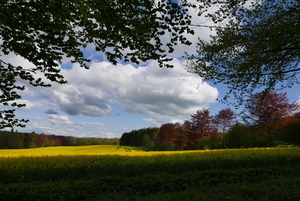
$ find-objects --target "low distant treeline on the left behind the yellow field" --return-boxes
[0,131,119,149]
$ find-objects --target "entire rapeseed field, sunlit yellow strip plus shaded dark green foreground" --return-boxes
[0,145,300,201]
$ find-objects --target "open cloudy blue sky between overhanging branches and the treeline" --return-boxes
[0,1,300,138]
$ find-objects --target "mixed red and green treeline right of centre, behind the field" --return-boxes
[120,91,300,150]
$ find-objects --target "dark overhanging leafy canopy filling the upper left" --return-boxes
[0,0,193,128]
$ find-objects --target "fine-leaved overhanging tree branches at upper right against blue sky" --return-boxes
[188,0,300,104]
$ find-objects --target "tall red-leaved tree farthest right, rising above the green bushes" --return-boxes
[243,91,299,145]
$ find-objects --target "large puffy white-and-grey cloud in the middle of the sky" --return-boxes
[56,59,218,122]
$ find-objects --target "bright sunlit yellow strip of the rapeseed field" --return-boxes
[0,145,299,159]
